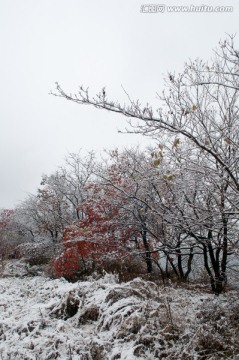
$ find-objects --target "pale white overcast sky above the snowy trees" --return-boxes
[0,0,239,208]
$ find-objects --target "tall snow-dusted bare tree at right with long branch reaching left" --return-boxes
[53,36,239,293]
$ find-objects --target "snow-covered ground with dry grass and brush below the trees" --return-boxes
[0,262,239,360]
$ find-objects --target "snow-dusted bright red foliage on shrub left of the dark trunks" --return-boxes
[53,190,134,278]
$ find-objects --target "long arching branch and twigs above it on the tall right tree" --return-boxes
[53,37,239,191]
